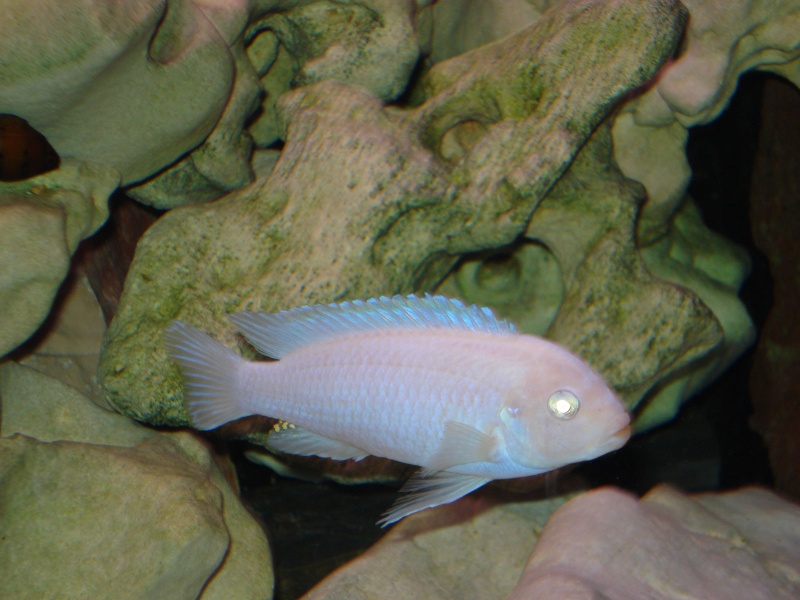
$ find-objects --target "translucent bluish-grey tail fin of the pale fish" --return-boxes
[164,321,253,429]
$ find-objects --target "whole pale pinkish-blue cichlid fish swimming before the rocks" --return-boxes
[165,296,630,525]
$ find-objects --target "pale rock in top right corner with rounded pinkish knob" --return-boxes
[614,0,800,243]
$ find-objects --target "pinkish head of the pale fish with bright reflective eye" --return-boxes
[500,340,630,472]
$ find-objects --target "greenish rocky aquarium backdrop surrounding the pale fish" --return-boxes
[0,0,800,600]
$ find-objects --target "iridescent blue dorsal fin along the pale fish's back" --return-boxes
[229,294,516,358]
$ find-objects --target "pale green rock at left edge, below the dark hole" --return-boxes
[0,160,119,355]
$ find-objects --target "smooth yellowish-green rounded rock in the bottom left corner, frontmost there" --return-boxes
[0,436,229,599]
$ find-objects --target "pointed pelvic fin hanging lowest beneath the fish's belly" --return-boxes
[378,471,491,527]
